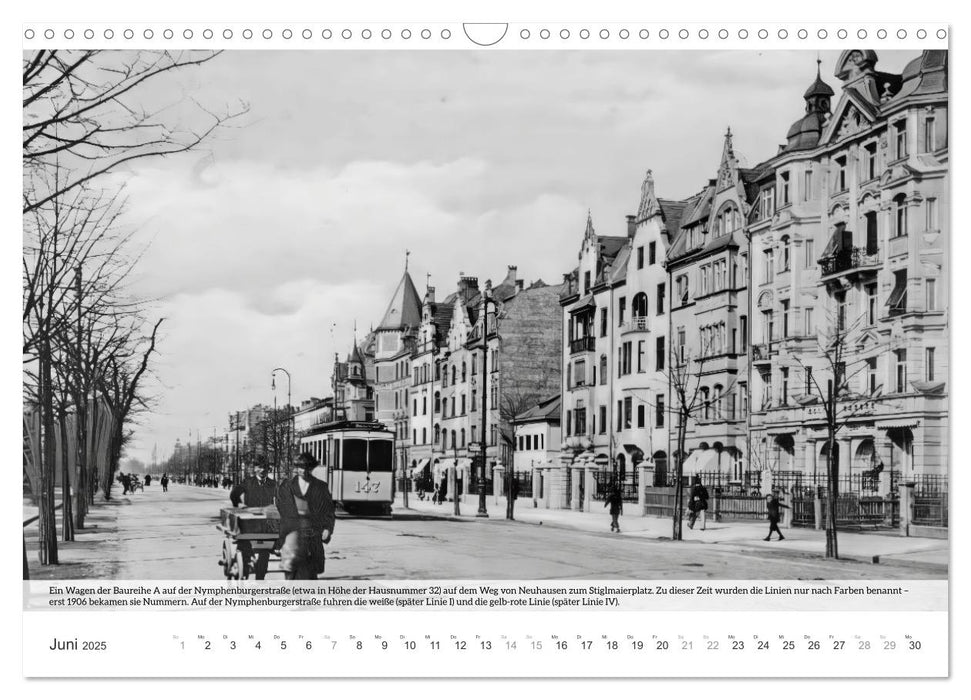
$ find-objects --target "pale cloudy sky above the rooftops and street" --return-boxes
[106,51,914,461]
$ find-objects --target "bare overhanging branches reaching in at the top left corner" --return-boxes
[23,50,248,214]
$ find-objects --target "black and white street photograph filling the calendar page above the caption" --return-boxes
[22,45,951,583]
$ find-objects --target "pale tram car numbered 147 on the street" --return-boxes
[300,421,394,515]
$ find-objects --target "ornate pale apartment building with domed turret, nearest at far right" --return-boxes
[748,50,949,476]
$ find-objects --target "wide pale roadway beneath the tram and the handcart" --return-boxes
[24,485,940,580]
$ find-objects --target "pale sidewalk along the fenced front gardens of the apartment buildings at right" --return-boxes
[394,493,950,573]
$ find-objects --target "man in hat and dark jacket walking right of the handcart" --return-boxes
[276,452,336,580]
